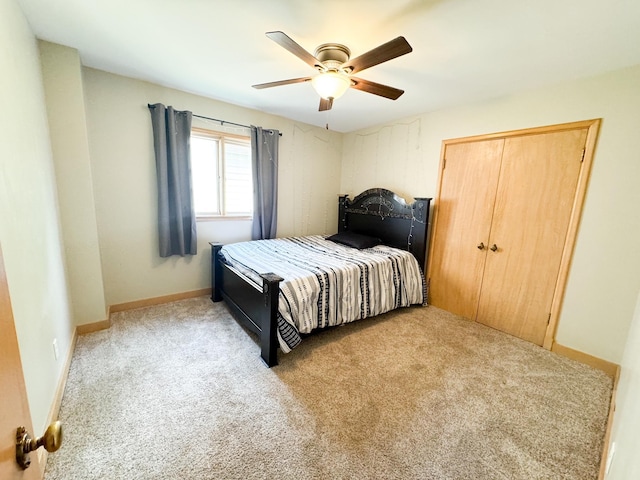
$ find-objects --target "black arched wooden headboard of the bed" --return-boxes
[338,188,431,269]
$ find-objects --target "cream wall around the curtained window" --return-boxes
[83,68,342,305]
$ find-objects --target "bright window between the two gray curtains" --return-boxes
[191,128,253,217]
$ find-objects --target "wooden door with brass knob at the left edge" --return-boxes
[0,244,42,480]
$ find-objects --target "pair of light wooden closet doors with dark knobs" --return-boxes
[428,120,599,348]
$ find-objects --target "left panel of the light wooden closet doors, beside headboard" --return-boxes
[429,139,504,319]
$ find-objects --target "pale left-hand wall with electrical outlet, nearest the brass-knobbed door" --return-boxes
[0,0,74,434]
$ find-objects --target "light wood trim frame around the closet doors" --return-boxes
[427,118,602,350]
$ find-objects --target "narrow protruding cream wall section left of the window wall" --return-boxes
[38,41,107,325]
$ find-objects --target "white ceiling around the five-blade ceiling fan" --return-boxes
[18,0,640,132]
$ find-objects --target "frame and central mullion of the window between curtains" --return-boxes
[191,127,253,221]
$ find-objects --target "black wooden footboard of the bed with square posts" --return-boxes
[210,242,282,367]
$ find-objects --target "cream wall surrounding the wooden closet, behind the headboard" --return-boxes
[342,66,640,363]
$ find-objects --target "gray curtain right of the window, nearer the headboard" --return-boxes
[251,125,280,240]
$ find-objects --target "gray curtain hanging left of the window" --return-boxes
[149,103,197,257]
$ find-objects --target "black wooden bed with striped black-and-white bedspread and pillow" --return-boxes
[211,188,431,367]
